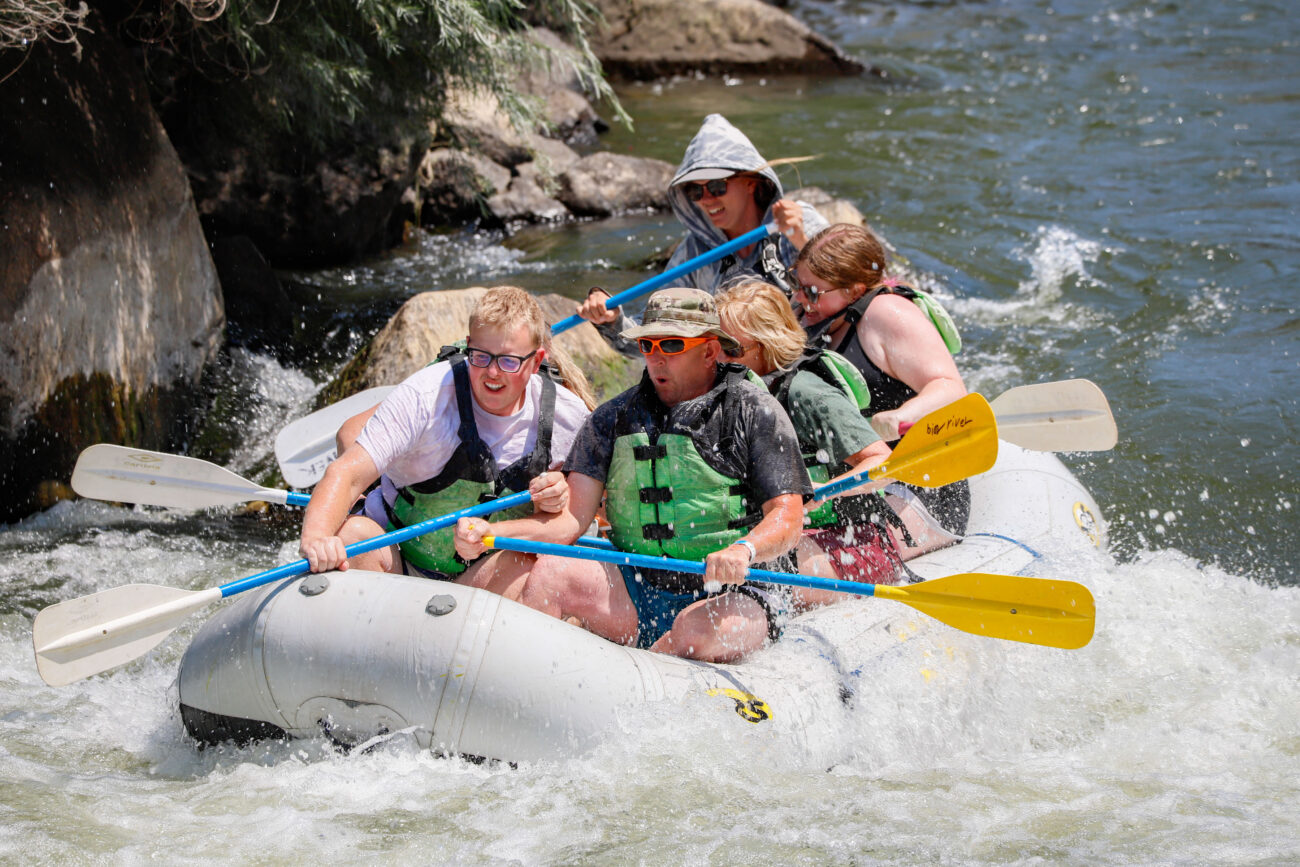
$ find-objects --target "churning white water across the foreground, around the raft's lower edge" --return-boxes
[0,519,1300,863]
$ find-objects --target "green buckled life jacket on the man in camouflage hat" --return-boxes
[605,365,762,560]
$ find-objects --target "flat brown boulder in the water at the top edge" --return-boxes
[590,0,865,79]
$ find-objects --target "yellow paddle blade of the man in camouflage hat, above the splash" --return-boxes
[875,572,1097,650]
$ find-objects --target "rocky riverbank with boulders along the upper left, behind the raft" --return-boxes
[0,0,863,520]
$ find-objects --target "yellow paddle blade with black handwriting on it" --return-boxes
[871,394,997,487]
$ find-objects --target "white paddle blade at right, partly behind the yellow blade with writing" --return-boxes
[992,380,1119,451]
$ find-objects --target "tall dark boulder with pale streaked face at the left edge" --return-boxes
[0,16,225,520]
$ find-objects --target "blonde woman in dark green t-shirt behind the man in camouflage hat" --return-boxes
[716,281,906,607]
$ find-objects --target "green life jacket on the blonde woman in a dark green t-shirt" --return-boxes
[764,346,875,528]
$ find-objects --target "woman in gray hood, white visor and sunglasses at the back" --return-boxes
[577,114,828,348]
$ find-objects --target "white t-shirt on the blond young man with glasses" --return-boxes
[356,361,590,504]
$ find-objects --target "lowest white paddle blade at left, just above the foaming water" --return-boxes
[31,584,221,686]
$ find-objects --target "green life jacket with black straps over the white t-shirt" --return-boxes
[389,350,555,575]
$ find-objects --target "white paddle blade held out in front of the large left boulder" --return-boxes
[73,443,286,508]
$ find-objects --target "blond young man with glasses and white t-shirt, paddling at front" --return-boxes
[299,286,589,585]
